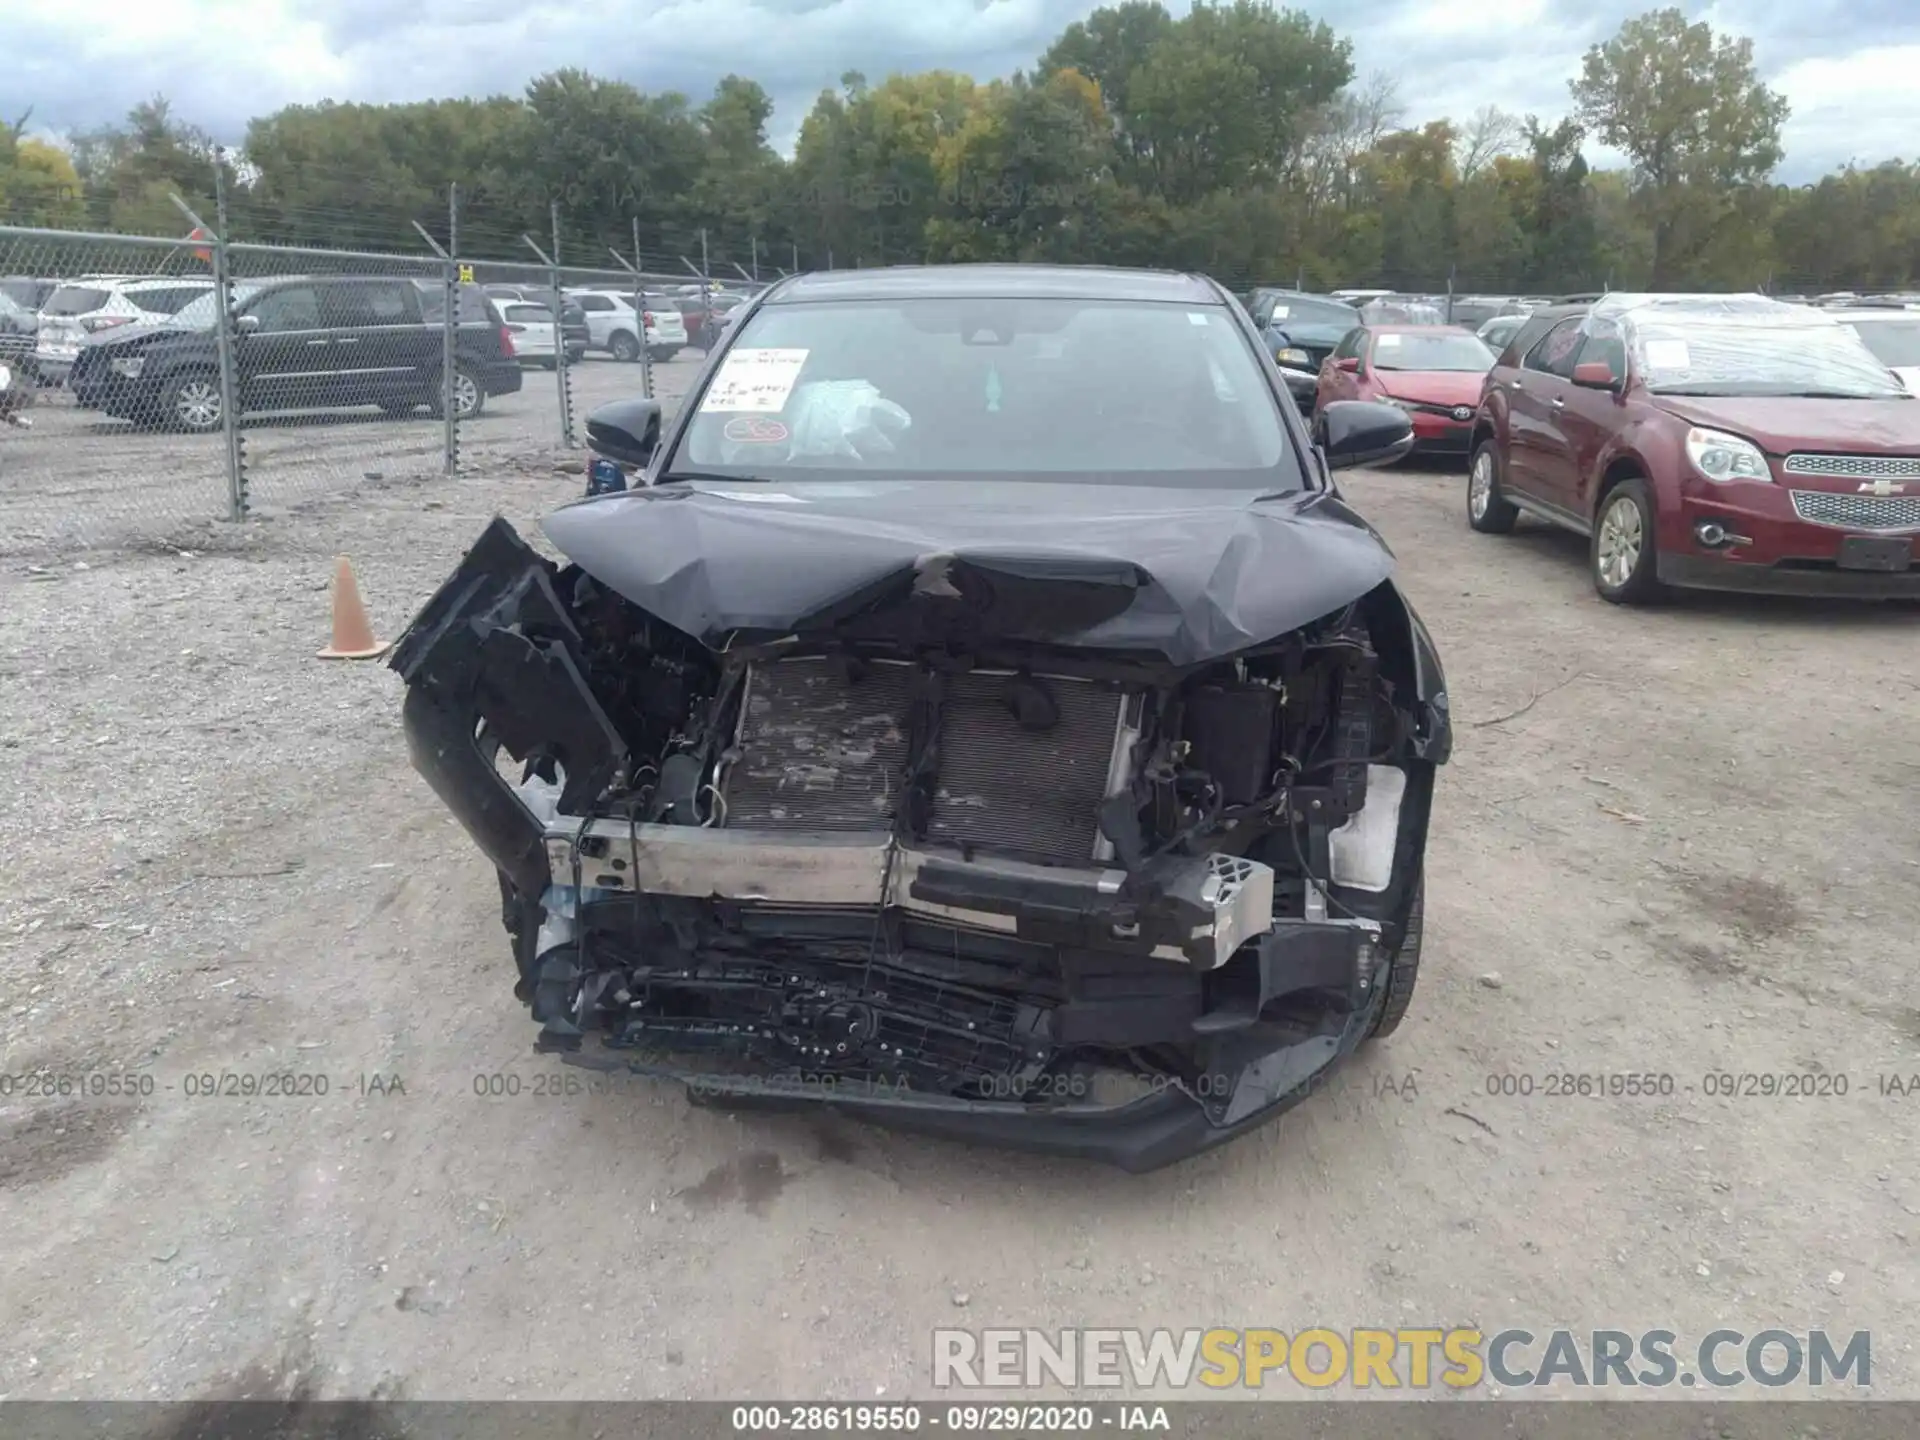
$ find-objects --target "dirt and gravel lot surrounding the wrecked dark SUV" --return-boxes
[0,437,1920,1398]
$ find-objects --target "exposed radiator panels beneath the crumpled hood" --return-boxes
[720,657,1129,866]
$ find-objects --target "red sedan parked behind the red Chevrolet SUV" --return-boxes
[1315,324,1496,457]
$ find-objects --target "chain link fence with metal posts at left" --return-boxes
[0,207,747,553]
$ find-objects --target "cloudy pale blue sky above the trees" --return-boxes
[15,0,1920,182]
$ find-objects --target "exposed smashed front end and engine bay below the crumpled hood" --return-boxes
[394,522,1432,1106]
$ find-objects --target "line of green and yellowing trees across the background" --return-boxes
[0,0,1920,290]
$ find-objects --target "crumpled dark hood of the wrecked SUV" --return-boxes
[543,480,1394,666]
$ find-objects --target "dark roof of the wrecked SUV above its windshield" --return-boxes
[766,265,1227,305]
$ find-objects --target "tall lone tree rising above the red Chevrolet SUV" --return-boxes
[1571,10,1788,290]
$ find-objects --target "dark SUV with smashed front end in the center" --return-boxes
[392,265,1452,1169]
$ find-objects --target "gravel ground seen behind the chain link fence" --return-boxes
[0,359,705,557]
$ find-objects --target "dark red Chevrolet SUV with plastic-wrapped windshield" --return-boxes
[1467,294,1920,603]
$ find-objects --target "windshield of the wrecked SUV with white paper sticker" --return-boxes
[666,296,1302,490]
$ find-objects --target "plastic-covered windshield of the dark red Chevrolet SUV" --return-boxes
[1634,321,1908,399]
